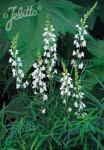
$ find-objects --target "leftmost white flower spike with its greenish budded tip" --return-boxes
[9,35,29,89]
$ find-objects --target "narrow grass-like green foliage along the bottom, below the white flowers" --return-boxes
[0,88,104,150]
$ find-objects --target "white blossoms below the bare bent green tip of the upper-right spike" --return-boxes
[71,25,88,69]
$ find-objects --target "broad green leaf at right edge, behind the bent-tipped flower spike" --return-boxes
[84,38,104,90]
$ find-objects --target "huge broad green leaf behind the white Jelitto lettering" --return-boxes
[0,0,80,72]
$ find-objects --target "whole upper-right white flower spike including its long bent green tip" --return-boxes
[71,3,97,69]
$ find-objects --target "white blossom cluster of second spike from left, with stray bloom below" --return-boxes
[31,56,48,113]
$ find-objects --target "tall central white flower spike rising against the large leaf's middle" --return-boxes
[43,17,57,77]
